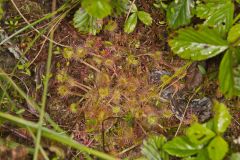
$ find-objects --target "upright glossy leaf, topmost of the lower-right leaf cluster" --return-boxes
[213,101,231,133]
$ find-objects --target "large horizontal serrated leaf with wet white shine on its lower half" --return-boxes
[169,28,228,60]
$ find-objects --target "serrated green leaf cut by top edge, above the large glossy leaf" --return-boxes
[167,0,194,28]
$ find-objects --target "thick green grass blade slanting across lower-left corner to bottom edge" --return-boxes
[0,112,117,160]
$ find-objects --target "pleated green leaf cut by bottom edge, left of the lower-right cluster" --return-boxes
[141,135,169,160]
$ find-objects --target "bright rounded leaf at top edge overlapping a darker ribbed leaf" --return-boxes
[82,0,112,19]
